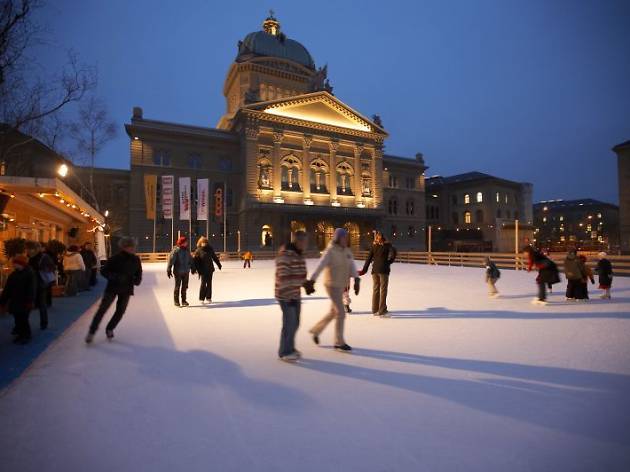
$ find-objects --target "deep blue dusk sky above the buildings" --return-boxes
[36,0,630,203]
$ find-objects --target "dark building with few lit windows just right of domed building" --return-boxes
[425,172,534,252]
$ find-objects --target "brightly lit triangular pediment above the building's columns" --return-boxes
[246,92,385,134]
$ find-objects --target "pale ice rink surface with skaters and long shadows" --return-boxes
[0,261,630,472]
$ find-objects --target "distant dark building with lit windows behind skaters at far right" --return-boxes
[534,198,619,252]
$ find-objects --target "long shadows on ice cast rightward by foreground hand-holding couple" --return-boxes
[299,349,630,445]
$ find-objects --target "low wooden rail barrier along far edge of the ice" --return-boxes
[138,251,630,276]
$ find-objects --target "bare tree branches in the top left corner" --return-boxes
[0,0,96,160]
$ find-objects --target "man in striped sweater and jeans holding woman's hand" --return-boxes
[276,231,315,362]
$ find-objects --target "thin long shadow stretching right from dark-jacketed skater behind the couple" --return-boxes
[389,306,630,320]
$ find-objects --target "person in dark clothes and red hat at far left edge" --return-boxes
[0,254,36,344]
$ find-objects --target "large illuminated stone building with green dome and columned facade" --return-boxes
[125,14,426,252]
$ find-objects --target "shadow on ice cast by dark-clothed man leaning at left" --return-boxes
[103,342,312,411]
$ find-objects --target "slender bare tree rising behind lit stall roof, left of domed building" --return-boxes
[70,95,116,210]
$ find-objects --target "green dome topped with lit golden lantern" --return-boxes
[236,13,315,70]
